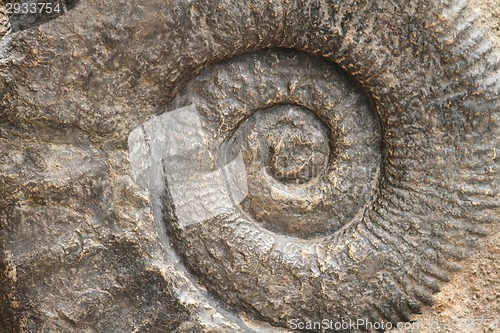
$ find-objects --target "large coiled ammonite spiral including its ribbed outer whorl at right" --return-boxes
[138,3,497,327]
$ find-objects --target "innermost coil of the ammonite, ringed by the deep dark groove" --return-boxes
[224,97,377,238]
